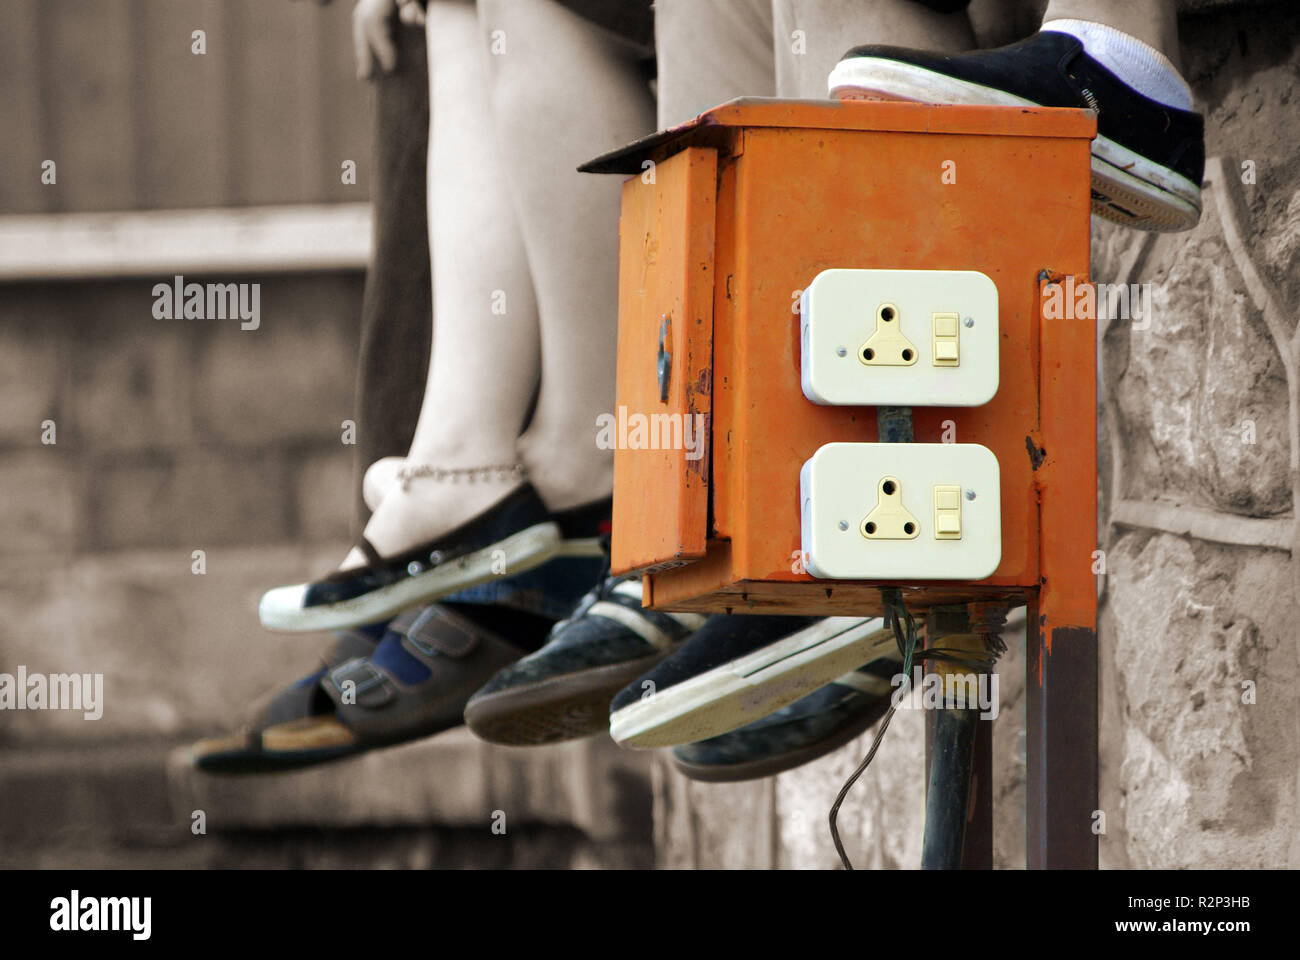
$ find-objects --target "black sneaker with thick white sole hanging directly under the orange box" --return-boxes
[610,615,897,748]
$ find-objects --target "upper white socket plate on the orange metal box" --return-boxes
[800,269,998,407]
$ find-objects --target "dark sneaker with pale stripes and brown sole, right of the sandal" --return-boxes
[465,578,705,747]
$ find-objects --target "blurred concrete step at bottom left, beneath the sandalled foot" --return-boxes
[0,728,654,869]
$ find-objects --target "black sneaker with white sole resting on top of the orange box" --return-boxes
[829,30,1205,230]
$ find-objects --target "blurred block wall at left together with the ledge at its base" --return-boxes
[0,272,653,868]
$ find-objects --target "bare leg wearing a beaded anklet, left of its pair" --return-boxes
[343,0,540,567]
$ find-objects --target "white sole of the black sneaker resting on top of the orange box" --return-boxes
[828,57,1201,232]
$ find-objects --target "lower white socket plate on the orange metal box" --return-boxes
[800,444,1002,580]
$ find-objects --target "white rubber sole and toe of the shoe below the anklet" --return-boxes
[257,520,562,631]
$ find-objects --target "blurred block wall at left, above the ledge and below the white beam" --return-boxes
[0,274,361,743]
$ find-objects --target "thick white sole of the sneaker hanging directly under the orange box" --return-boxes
[610,617,898,749]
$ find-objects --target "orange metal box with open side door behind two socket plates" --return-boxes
[585,100,1096,621]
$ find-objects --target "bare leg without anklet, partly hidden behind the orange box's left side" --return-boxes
[478,0,654,510]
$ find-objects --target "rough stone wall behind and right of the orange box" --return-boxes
[655,4,1300,868]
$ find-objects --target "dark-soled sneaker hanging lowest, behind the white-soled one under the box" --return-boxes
[672,657,902,783]
